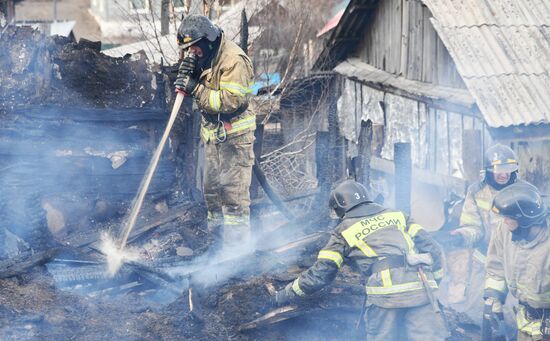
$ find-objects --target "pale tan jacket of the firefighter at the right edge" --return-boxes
[484,219,550,335]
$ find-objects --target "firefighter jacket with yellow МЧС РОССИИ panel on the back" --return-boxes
[292,203,443,308]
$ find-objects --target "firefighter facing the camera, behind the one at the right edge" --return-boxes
[449,144,522,325]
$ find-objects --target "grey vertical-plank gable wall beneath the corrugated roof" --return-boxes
[350,0,466,89]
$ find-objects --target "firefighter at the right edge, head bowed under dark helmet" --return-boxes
[484,182,550,341]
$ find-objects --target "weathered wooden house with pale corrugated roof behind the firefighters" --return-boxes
[284,0,550,227]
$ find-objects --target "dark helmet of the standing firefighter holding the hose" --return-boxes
[178,14,221,49]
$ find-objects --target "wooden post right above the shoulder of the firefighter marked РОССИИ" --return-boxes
[393,142,412,214]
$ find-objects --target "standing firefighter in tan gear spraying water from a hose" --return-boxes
[175,15,256,246]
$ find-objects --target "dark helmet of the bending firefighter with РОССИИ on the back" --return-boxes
[329,180,371,218]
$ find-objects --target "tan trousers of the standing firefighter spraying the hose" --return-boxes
[203,131,254,246]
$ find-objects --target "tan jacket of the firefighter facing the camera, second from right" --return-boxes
[460,180,522,264]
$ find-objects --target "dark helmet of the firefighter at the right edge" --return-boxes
[492,182,547,228]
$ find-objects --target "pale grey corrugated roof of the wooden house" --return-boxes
[422,0,550,128]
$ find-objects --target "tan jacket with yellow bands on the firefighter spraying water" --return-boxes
[193,34,256,143]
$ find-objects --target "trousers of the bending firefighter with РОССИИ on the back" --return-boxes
[365,304,447,341]
